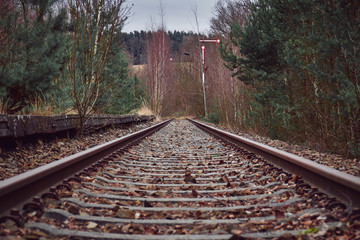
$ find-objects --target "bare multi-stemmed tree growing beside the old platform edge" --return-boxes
[67,0,130,130]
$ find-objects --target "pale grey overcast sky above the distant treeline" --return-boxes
[124,0,218,33]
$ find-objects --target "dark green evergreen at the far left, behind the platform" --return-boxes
[0,0,68,114]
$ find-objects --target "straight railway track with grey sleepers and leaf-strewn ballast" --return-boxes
[0,121,360,239]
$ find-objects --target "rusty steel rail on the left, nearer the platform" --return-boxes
[0,120,171,216]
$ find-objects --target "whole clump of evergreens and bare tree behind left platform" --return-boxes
[0,0,144,121]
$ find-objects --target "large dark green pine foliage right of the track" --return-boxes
[220,0,360,156]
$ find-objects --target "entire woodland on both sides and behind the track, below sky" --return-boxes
[0,0,360,158]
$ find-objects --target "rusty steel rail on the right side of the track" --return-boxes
[188,119,360,209]
